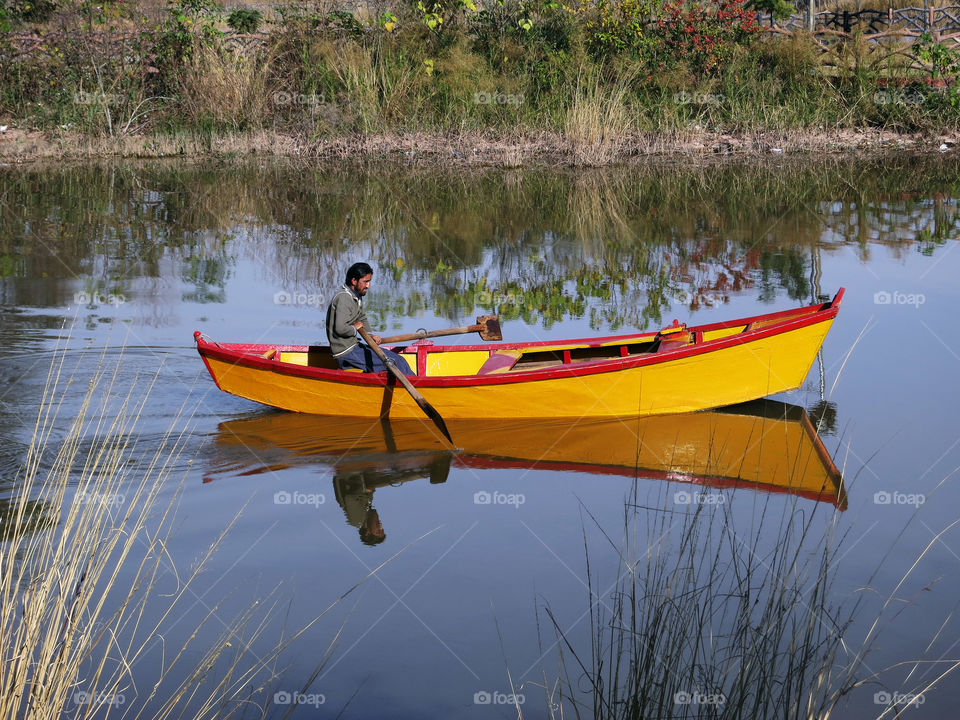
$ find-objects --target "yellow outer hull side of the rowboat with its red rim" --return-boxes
[197,291,842,420]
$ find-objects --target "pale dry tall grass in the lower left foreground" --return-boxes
[0,344,369,720]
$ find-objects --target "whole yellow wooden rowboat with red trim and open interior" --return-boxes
[194,289,843,422]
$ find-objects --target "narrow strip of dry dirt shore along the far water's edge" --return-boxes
[0,124,960,167]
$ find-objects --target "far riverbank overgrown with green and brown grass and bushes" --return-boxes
[0,0,960,165]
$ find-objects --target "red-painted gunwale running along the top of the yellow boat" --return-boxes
[194,288,845,389]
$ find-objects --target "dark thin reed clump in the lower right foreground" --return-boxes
[535,470,960,720]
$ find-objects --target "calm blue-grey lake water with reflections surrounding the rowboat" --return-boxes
[0,157,960,718]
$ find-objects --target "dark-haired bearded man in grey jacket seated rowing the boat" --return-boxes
[327,262,414,375]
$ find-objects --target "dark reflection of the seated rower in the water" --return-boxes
[333,452,451,545]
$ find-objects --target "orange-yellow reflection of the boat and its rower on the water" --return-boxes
[205,400,847,544]
